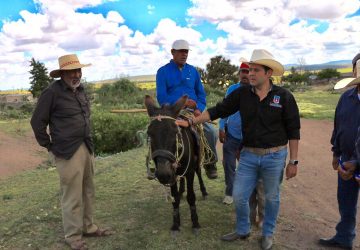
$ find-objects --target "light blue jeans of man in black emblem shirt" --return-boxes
[233,148,287,236]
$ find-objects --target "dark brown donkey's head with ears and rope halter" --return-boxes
[145,95,187,185]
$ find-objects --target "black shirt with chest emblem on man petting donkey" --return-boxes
[208,85,300,148]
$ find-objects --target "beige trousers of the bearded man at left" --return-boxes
[54,143,98,242]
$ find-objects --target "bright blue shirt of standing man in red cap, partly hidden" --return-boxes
[219,82,243,140]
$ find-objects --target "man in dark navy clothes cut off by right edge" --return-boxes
[319,53,360,249]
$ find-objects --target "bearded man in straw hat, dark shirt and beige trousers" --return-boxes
[31,55,111,249]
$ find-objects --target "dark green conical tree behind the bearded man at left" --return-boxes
[29,58,53,97]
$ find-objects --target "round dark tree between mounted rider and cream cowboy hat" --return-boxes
[200,56,239,88]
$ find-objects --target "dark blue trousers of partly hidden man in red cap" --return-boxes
[223,133,242,196]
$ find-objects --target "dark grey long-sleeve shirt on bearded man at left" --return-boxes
[30,80,93,159]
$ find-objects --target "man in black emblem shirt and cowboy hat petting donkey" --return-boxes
[177,49,300,249]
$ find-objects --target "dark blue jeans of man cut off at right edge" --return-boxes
[334,176,359,246]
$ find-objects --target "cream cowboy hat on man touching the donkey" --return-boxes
[249,49,285,76]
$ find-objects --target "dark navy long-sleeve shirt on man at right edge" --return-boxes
[330,88,360,161]
